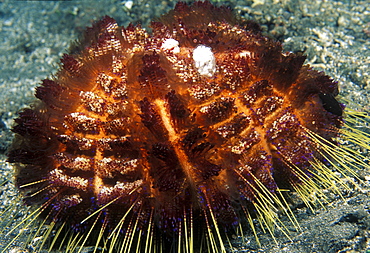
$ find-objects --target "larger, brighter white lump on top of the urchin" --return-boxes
[193,45,216,77]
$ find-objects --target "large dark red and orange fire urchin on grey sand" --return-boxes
[9,2,342,251]
